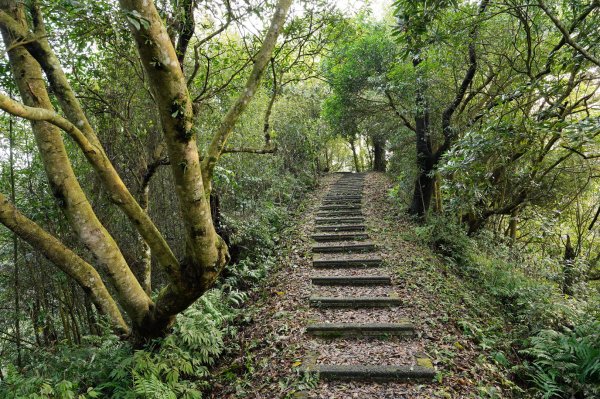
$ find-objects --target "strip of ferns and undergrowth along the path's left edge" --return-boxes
[0,178,308,399]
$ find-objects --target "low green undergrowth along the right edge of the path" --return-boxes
[407,217,600,399]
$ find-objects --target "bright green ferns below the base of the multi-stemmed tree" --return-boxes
[0,287,247,399]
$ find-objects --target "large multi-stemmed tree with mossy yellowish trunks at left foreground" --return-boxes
[0,0,292,341]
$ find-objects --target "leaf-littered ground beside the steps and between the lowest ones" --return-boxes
[206,173,514,399]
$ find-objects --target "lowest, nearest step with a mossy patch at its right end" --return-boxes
[310,364,436,382]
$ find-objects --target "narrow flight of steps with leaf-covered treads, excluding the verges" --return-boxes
[304,174,435,383]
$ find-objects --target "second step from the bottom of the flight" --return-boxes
[306,322,415,338]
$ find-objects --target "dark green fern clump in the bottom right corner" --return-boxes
[521,320,600,399]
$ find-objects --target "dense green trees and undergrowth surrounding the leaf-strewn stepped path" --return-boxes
[0,0,600,398]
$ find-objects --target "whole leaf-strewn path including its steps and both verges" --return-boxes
[207,173,494,399]
